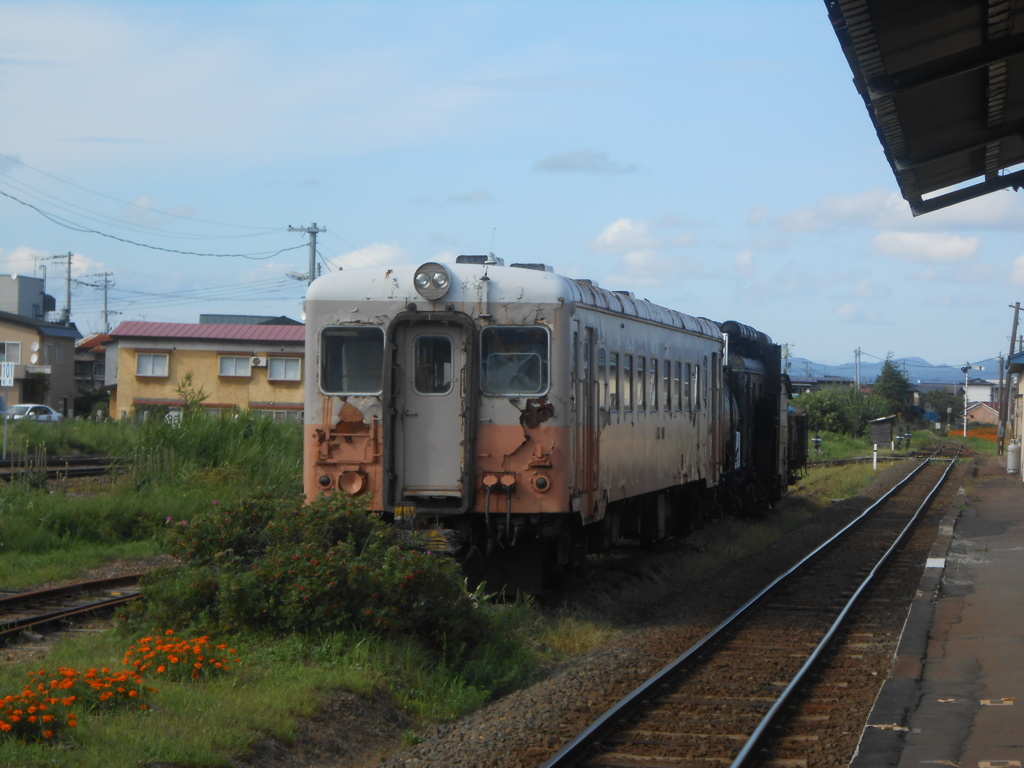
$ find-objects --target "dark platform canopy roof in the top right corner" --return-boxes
[824,0,1024,216]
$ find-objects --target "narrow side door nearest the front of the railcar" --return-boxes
[572,325,598,520]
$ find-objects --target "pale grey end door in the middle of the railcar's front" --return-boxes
[391,322,470,511]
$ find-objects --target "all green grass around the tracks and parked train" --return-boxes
[0,418,913,768]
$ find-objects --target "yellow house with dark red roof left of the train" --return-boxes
[104,321,305,420]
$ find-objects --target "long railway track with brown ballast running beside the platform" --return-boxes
[543,448,953,768]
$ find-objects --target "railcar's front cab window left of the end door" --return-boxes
[319,326,384,394]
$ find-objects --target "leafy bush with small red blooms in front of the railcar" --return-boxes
[135,495,488,658]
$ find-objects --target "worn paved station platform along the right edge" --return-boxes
[850,457,1024,768]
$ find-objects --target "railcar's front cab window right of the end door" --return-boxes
[480,326,550,395]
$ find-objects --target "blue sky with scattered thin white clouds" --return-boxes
[0,0,1024,372]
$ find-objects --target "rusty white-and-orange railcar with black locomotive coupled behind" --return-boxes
[304,255,807,590]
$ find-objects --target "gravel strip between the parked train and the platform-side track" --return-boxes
[237,456,942,768]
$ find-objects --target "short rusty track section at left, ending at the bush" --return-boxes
[0,573,141,643]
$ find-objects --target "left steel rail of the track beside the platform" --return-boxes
[539,447,959,768]
